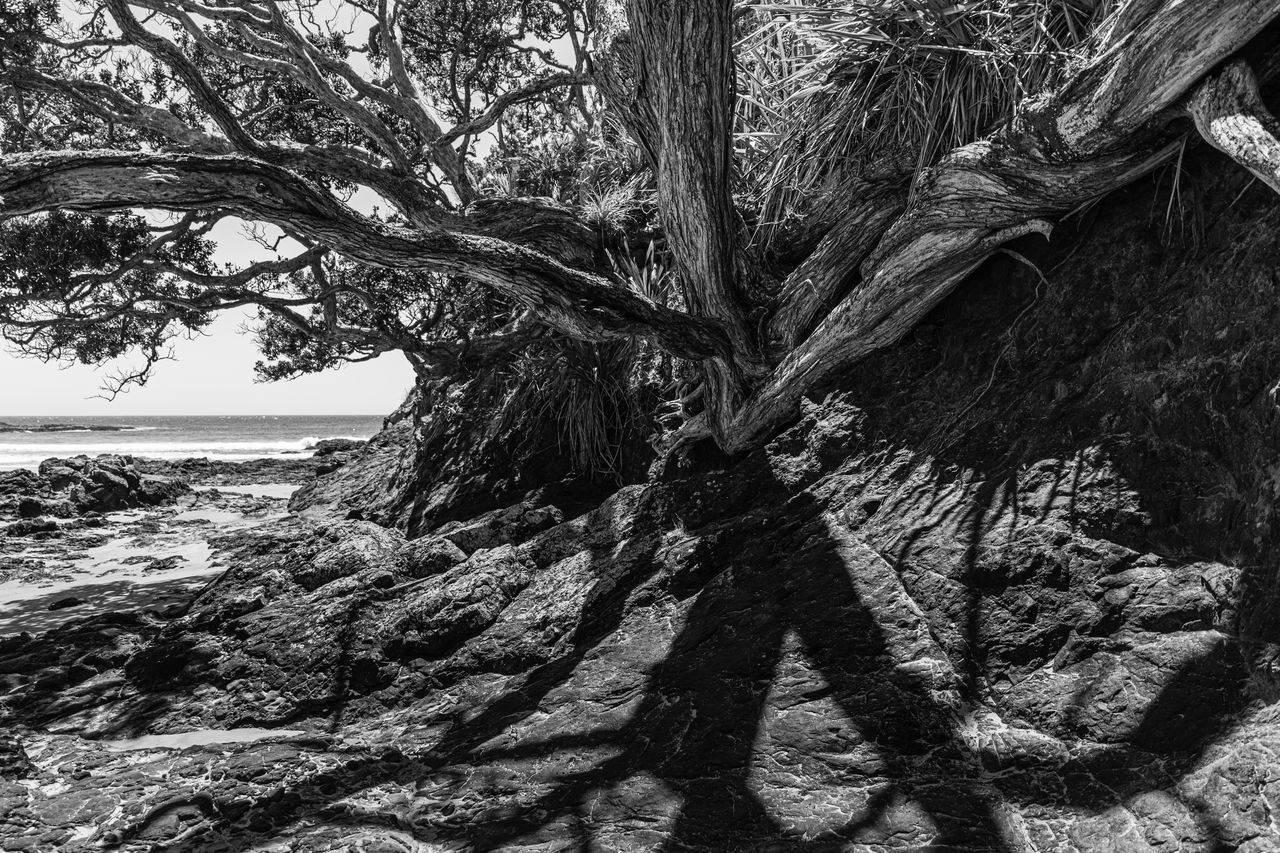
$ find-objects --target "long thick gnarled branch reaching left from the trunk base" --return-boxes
[0,151,730,359]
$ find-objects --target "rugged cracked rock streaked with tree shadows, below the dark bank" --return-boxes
[0,398,1280,853]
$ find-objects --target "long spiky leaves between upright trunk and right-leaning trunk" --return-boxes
[737,0,1114,243]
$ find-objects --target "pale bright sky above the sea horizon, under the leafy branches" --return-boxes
[0,216,413,420]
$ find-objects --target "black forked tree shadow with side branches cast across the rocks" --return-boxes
[137,458,1239,852]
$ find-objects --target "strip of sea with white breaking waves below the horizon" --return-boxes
[0,414,383,470]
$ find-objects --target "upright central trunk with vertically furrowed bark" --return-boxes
[598,0,758,438]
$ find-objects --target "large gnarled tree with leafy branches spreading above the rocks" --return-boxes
[0,0,1280,452]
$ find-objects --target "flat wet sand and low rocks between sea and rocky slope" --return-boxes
[0,442,364,640]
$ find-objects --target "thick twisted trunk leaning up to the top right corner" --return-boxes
[722,0,1280,451]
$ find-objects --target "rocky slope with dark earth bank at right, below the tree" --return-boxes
[0,144,1280,850]
